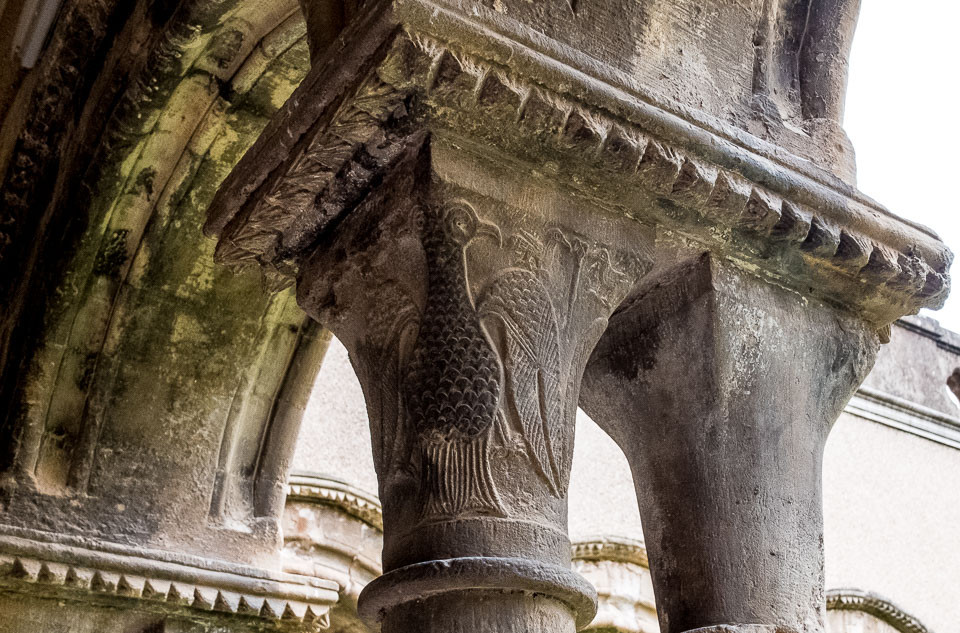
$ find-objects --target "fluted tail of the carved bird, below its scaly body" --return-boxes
[420,434,506,521]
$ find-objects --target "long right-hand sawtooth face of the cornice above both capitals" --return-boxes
[380,25,950,320]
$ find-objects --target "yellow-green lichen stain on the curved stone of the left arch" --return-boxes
[0,8,309,528]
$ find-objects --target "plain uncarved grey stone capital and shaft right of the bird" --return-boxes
[583,255,879,633]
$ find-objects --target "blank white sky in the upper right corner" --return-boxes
[844,0,960,331]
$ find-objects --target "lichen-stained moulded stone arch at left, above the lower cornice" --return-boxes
[0,0,349,565]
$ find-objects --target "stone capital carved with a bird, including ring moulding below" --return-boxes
[298,141,645,633]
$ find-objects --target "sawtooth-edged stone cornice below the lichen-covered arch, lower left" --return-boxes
[0,530,338,630]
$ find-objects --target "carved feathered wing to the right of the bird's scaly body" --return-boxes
[478,269,565,494]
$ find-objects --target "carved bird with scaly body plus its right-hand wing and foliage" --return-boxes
[403,203,632,521]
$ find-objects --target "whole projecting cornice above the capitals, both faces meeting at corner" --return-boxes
[207,0,952,325]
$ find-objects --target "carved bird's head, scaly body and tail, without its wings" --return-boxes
[404,205,505,520]
